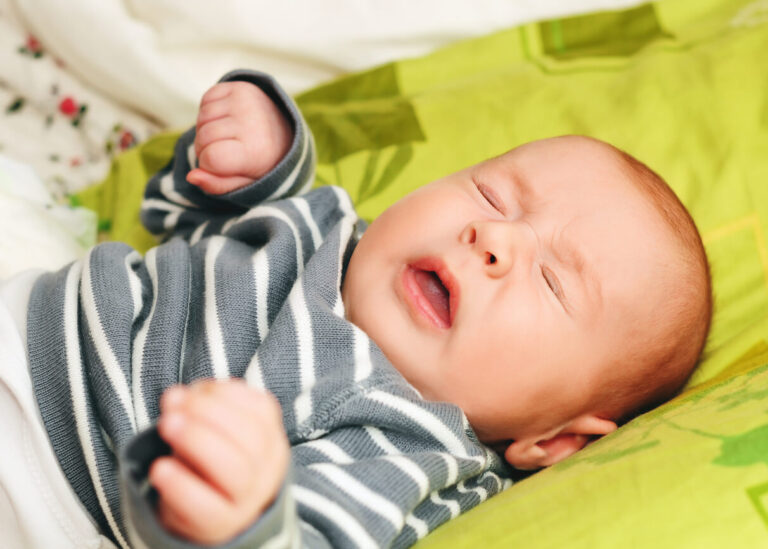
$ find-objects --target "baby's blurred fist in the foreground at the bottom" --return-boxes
[149,380,290,545]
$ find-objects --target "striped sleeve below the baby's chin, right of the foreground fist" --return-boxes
[280,388,509,548]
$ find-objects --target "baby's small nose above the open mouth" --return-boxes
[460,220,537,278]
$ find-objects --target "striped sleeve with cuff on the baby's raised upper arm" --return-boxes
[141,70,315,244]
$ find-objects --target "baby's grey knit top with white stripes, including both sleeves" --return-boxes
[27,71,509,549]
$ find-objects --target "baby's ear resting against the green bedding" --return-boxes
[504,414,616,470]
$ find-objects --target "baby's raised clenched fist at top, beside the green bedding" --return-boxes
[187,82,293,194]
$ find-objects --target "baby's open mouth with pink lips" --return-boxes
[404,260,458,328]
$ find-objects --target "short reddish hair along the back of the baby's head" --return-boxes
[599,142,713,423]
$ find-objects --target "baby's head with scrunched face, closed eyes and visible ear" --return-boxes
[342,136,712,468]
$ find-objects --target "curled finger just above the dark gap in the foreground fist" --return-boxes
[157,411,254,501]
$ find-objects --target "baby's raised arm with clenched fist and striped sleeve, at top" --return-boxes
[141,71,315,242]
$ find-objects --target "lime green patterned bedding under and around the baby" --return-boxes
[75,0,768,549]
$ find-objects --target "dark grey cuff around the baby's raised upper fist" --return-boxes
[217,69,315,204]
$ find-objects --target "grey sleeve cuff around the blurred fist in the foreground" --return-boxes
[120,427,297,549]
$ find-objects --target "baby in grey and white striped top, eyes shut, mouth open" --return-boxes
[1,71,711,548]
